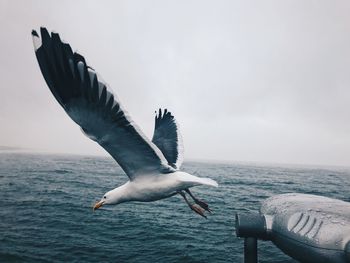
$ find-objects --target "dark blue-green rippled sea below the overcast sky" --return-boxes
[0,152,350,263]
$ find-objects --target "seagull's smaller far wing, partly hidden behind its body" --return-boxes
[152,109,184,169]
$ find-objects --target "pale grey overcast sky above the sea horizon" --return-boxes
[0,0,350,166]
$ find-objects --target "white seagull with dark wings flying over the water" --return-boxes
[32,27,218,218]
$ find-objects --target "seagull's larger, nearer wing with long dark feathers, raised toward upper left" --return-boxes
[32,28,174,180]
